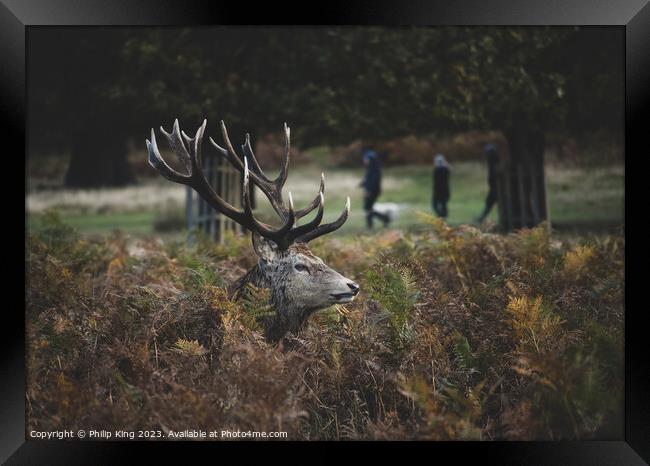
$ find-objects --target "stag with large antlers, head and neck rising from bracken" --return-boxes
[146,120,359,342]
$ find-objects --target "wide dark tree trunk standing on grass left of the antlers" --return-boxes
[65,127,135,188]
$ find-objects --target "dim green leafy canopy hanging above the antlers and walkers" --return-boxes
[118,27,622,142]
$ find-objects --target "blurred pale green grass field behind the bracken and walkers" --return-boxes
[27,162,624,238]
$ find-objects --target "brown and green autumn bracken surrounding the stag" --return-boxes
[26,214,624,440]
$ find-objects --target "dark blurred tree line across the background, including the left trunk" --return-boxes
[28,27,624,187]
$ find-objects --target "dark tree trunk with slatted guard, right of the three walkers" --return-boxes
[498,126,548,232]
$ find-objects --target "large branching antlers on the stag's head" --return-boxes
[146,119,350,249]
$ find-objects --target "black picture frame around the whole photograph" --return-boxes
[0,0,650,465]
